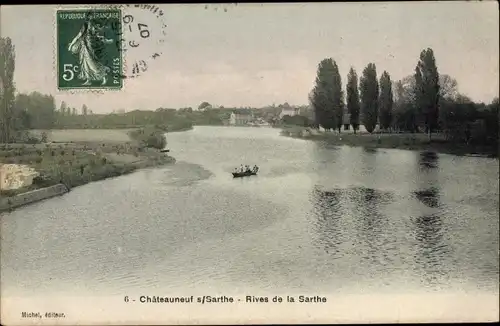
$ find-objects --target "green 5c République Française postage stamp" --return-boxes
[56,8,123,90]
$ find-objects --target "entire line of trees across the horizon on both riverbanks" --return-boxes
[0,37,499,144]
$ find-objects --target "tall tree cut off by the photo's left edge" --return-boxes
[0,37,16,143]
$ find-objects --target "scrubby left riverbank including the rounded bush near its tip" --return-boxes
[0,128,175,206]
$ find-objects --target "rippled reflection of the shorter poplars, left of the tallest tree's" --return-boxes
[311,186,394,268]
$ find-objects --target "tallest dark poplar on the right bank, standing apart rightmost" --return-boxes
[415,48,440,141]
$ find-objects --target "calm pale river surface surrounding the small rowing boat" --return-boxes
[1,127,499,296]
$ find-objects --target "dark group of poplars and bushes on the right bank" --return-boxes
[309,48,499,144]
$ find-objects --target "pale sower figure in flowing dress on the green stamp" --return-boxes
[68,17,113,85]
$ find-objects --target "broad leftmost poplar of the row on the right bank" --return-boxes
[309,58,338,130]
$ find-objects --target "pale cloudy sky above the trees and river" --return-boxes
[0,1,499,113]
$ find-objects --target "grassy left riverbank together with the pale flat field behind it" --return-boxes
[0,130,175,196]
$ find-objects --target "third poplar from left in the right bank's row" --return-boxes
[359,63,379,133]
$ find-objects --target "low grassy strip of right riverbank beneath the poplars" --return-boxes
[281,126,498,157]
